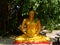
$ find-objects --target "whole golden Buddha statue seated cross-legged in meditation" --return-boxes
[15,10,50,42]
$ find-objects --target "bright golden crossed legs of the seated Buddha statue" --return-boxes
[15,34,50,42]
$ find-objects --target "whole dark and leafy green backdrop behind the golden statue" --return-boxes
[0,0,60,36]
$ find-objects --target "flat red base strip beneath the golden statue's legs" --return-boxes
[14,41,51,45]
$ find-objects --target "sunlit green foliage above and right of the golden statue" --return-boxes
[17,0,60,31]
